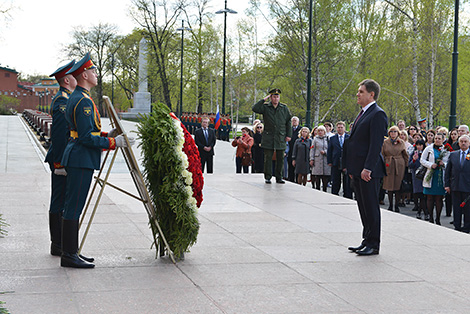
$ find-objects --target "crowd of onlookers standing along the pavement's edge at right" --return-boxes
[232,116,470,232]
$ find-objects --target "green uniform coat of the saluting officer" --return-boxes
[252,99,292,151]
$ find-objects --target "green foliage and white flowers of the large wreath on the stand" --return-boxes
[138,104,199,258]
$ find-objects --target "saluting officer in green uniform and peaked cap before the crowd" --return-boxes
[252,88,292,184]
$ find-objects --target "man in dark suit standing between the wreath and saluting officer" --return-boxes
[194,117,216,173]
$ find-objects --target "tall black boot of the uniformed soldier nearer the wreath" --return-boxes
[60,219,95,268]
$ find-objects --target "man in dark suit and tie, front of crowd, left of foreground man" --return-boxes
[326,121,352,198]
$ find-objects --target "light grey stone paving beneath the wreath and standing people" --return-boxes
[0,116,470,313]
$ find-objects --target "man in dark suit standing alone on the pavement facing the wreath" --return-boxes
[344,79,388,255]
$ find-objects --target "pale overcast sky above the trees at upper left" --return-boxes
[0,0,248,76]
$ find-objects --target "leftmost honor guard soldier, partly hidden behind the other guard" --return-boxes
[45,60,77,256]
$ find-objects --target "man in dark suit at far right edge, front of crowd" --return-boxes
[444,135,470,233]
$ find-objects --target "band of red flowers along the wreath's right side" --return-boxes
[170,113,204,208]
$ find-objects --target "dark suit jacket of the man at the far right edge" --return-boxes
[445,150,470,193]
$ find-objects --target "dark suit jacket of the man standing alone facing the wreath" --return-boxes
[343,103,388,178]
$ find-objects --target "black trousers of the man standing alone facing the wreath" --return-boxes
[353,176,380,249]
